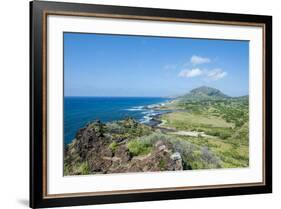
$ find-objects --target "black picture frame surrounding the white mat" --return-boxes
[30,1,272,208]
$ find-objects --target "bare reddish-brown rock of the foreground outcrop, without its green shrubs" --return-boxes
[64,121,183,175]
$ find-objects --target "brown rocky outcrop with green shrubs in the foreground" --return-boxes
[64,119,186,175]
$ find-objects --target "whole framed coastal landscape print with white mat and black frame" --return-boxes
[30,1,272,208]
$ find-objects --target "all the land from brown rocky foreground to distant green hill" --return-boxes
[64,86,249,176]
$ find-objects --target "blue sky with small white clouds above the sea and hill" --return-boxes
[64,33,249,97]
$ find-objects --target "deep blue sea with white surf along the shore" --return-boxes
[64,97,169,144]
